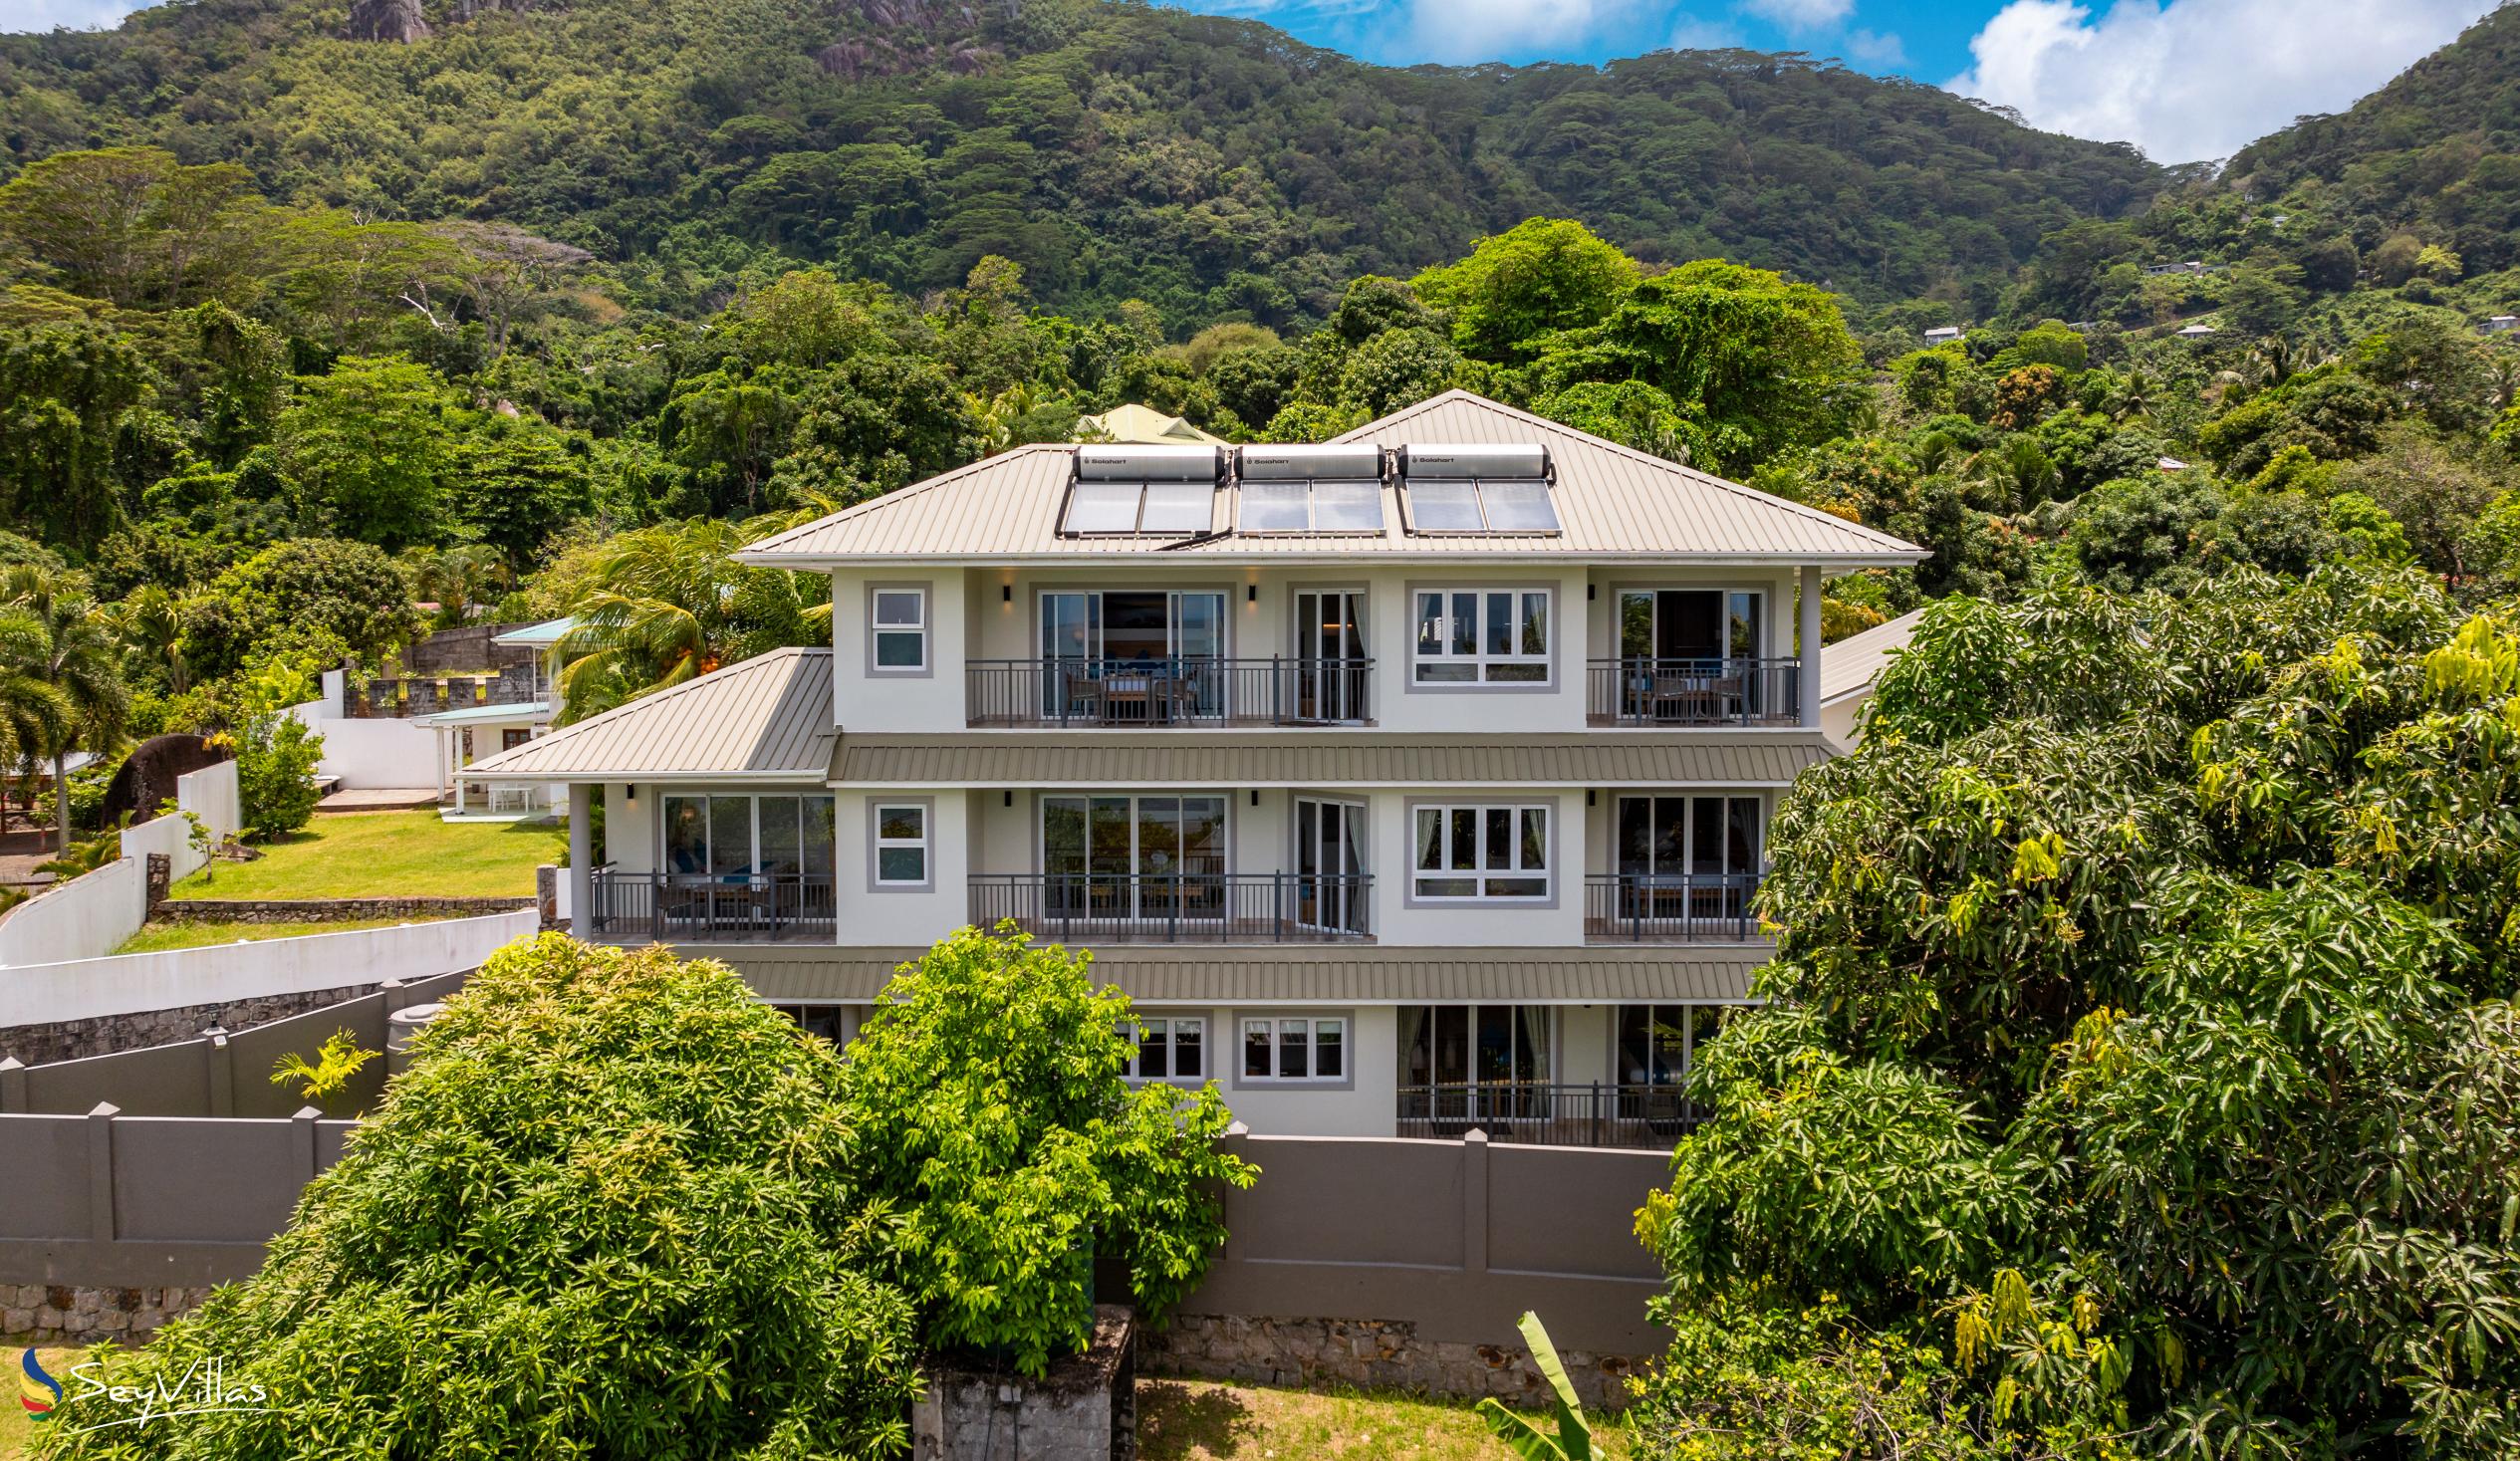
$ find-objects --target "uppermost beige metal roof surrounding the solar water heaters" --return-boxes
[738,390,1925,567]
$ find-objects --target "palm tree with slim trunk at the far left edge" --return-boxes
[0,565,128,852]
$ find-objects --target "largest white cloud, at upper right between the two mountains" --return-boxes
[1948,0,2495,161]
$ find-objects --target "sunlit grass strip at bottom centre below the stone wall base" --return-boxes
[1136,1380,1628,1461]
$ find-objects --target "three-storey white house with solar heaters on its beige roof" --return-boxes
[461,390,1925,1143]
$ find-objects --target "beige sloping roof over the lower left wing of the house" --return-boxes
[456,650,839,781]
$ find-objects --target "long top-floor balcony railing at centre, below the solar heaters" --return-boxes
[962,657,1374,728]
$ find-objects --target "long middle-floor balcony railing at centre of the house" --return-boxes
[970,871,1374,944]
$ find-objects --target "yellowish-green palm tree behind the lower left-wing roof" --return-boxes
[557,519,832,720]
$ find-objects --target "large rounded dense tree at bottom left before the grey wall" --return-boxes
[46,934,914,1461]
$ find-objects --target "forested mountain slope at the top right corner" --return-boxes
[2222,8,2520,272]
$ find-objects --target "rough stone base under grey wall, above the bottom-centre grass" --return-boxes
[1136,1315,1638,1410]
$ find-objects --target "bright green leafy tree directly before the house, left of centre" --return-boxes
[842,929,1255,1375]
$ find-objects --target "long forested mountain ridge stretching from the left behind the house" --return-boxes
[0,0,2164,323]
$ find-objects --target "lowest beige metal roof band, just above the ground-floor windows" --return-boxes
[700,944,1774,1005]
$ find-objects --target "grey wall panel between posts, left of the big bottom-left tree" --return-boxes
[114,1115,315,1244]
